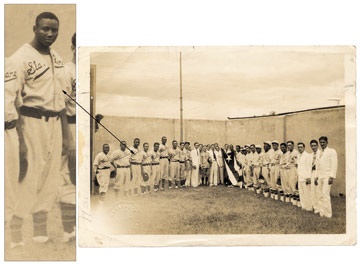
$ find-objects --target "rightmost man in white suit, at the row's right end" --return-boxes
[315,136,338,218]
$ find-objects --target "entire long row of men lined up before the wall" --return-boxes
[93,136,337,217]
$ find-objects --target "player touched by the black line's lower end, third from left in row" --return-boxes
[130,138,143,196]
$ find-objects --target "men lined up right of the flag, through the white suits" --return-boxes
[236,136,338,218]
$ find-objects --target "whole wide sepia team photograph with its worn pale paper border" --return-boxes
[78,46,356,247]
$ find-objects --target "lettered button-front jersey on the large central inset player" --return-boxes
[11,43,67,112]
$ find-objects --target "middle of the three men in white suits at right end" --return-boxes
[310,139,320,214]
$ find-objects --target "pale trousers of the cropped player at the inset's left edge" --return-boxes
[4,128,19,222]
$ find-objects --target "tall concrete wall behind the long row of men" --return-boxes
[94,107,345,195]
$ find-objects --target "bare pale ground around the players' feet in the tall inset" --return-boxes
[4,203,76,260]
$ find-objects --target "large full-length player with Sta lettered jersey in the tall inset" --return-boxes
[9,12,75,249]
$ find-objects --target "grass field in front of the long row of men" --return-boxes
[92,183,346,235]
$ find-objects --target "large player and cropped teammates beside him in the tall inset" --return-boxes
[4,12,76,252]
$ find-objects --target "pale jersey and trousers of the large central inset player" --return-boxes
[11,44,66,218]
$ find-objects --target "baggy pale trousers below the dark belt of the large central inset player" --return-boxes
[14,115,62,218]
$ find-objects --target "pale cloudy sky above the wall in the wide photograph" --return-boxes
[90,46,355,120]
